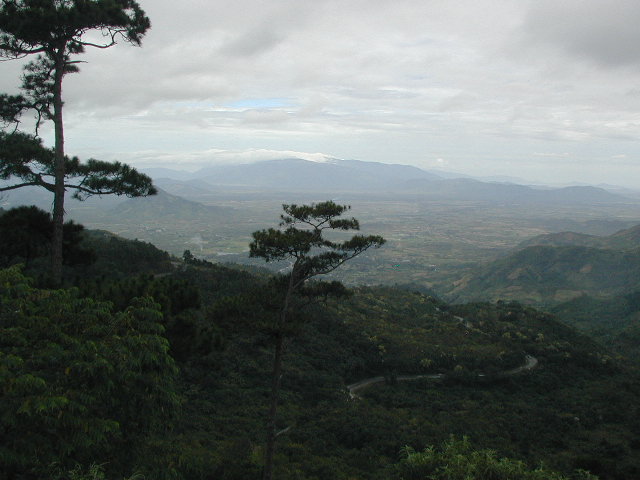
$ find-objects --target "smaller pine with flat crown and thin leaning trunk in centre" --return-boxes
[249,201,385,480]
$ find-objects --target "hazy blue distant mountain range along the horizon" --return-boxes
[144,158,635,204]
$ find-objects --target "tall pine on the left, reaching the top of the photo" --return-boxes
[0,0,152,283]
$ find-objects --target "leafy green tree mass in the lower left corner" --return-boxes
[0,268,177,478]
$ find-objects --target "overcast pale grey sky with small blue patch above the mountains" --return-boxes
[0,0,640,188]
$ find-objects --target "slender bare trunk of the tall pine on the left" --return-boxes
[51,50,65,285]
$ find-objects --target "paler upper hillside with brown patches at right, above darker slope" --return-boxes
[450,221,640,305]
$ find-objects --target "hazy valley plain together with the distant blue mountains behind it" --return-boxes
[4,158,640,301]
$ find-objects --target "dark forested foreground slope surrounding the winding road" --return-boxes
[0,223,640,480]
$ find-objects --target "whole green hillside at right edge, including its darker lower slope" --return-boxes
[444,221,640,352]
